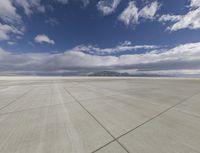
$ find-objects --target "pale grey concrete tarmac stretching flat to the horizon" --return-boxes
[0,77,200,153]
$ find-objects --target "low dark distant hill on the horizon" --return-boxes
[88,71,169,77]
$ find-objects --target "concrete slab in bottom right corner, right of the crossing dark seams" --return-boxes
[119,110,200,153]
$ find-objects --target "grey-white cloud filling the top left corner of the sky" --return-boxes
[0,0,21,23]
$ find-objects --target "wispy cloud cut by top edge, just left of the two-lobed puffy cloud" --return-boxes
[97,0,121,15]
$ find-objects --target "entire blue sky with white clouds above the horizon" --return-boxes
[0,0,200,76]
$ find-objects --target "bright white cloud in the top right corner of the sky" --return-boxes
[159,0,200,31]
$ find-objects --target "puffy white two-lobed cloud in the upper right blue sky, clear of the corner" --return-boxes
[118,1,160,26]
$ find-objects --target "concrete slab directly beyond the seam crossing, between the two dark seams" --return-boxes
[81,97,166,138]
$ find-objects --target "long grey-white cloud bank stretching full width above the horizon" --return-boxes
[0,42,200,74]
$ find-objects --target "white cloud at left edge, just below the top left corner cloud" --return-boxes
[0,23,23,41]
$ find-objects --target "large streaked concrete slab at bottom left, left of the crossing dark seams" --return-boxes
[0,104,112,153]
